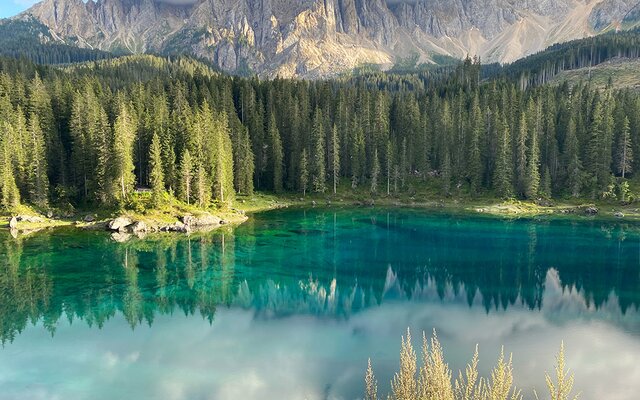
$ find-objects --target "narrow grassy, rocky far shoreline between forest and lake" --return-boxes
[0,194,640,241]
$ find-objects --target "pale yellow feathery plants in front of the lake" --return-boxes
[365,329,578,400]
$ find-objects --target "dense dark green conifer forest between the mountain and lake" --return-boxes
[0,46,640,209]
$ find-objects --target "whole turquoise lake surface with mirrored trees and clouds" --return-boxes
[0,209,640,400]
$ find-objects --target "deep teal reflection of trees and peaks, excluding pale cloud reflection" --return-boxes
[0,211,640,342]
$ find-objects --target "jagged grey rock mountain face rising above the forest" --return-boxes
[13,0,637,78]
